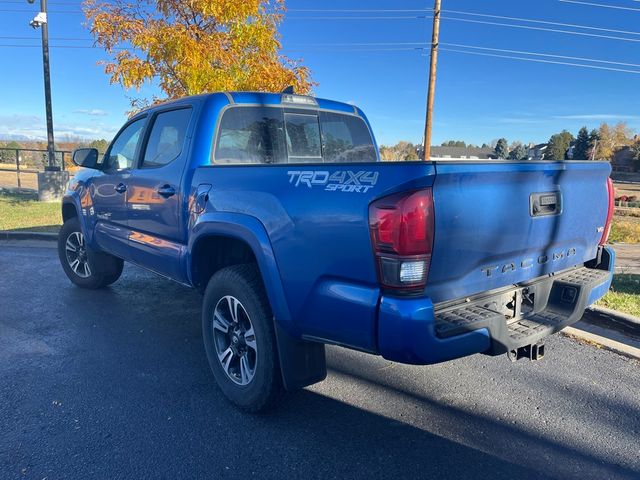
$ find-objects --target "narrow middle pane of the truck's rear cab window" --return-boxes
[284,113,322,163]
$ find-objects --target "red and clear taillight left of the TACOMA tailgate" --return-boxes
[369,189,433,291]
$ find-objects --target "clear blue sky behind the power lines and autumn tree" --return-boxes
[0,0,640,144]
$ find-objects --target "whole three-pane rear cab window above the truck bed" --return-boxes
[214,107,377,164]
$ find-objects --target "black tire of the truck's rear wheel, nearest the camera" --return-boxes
[202,264,284,413]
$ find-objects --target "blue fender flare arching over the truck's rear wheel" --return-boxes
[186,212,299,336]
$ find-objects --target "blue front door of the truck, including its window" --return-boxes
[89,117,147,260]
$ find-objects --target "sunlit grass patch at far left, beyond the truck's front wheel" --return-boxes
[0,193,62,232]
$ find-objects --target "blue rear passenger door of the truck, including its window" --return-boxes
[127,107,192,281]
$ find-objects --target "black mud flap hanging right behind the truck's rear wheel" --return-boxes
[274,321,327,391]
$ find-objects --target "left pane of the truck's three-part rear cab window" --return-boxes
[214,107,287,164]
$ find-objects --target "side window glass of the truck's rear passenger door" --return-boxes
[140,108,191,168]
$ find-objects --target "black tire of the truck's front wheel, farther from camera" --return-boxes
[58,217,124,290]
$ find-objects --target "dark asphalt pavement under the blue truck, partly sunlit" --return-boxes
[0,244,640,480]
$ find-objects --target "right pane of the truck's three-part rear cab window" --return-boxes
[320,112,378,163]
